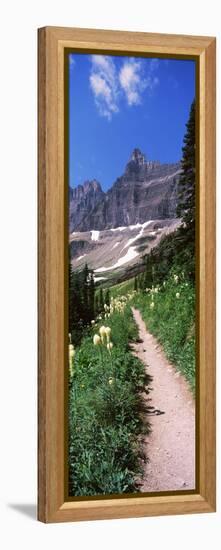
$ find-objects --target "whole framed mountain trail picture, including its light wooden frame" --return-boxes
[38,27,216,522]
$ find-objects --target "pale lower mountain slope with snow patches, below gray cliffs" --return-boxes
[70,219,180,285]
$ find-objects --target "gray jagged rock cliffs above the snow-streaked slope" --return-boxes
[70,149,181,231]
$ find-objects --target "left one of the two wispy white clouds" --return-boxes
[90,55,119,120]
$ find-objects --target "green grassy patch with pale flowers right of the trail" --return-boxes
[134,270,195,391]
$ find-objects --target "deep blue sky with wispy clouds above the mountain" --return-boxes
[69,53,195,190]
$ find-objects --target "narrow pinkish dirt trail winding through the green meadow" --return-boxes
[132,308,195,492]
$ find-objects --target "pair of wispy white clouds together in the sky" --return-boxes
[90,55,159,120]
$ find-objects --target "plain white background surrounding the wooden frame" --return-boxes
[0,0,221,550]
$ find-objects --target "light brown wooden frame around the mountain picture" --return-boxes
[38,27,216,522]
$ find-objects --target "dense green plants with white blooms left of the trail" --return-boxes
[69,306,152,496]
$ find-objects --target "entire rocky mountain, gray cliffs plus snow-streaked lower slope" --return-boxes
[69,148,181,286]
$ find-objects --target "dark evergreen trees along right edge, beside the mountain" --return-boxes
[134,100,196,290]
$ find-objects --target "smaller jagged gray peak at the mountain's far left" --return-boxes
[69,180,105,232]
